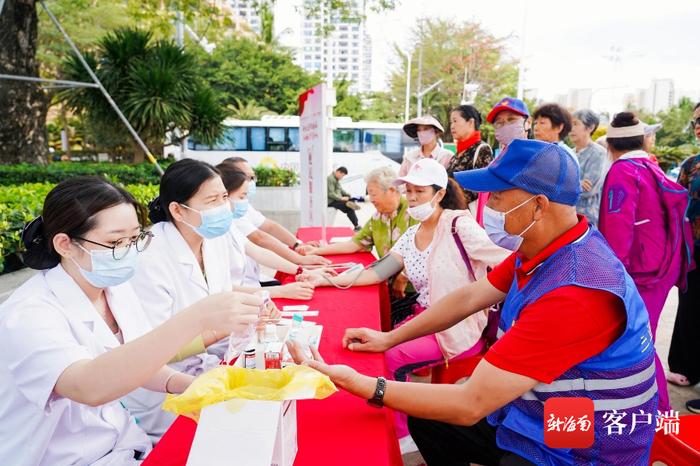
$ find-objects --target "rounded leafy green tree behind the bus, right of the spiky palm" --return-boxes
[197,38,321,114]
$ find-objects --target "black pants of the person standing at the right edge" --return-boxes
[668,247,700,385]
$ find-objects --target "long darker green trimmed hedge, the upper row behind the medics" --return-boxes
[0,161,298,186]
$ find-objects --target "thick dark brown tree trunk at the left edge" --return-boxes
[0,0,48,163]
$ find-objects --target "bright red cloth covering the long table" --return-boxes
[143,228,403,466]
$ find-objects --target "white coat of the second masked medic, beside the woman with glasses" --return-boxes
[124,222,233,441]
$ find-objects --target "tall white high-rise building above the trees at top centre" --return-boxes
[296,1,372,93]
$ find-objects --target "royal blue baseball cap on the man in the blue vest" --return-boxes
[454,139,581,205]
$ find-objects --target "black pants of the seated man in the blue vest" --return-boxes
[408,417,534,466]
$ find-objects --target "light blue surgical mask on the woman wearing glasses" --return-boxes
[71,243,139,288]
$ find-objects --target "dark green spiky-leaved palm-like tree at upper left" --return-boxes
[61,28,226,161]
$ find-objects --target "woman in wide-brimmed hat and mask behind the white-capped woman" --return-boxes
[399,115,452,176]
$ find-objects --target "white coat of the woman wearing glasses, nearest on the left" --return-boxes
[0,265,151,466]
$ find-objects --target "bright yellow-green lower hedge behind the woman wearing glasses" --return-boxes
[0,183,158,273]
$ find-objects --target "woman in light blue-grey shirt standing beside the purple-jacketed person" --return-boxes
[569,110,607,225]
